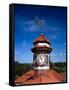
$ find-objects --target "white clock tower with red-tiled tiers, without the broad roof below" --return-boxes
[31,34,52,70]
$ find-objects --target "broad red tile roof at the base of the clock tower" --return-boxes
[15,69,65,84]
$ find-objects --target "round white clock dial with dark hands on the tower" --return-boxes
[36,53,48,65]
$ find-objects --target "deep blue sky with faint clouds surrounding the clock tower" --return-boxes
[14,5,67,63]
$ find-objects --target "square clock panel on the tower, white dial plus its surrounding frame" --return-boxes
[34,53,49,66]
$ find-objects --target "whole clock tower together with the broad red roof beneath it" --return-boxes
[15,34,65,85]
